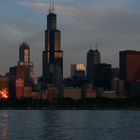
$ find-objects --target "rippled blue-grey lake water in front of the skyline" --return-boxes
[0,110,140,140]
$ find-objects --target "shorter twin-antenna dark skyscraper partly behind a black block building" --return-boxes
[87,44,101,82]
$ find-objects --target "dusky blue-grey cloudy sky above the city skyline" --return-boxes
[0,0,140,77]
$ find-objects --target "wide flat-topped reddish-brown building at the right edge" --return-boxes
[119,50,140,91]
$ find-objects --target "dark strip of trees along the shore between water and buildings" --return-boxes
[0,98,140,109]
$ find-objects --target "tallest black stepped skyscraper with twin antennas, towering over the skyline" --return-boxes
[43,2,63,84]
